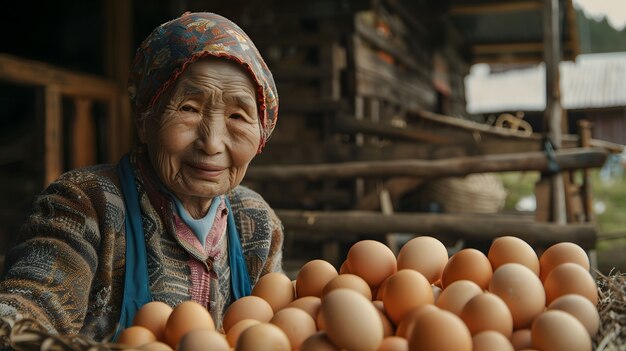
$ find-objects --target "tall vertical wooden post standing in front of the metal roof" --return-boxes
[543,0,567,224]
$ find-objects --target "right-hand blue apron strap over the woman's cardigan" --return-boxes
[224,196,252,300]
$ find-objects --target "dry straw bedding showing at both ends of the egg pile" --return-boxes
[0,272,626,351]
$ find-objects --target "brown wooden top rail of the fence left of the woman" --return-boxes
[0,54,119,101]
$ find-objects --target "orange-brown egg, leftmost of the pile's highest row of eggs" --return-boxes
[346,240,397,287]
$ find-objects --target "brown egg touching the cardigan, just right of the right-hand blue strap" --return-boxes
[252,272,295,313]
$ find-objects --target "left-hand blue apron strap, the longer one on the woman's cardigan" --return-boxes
[113,154,152,341]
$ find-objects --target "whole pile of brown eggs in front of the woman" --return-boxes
[118,236,600,351]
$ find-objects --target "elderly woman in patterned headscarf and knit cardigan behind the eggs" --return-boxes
[0,13,283,340]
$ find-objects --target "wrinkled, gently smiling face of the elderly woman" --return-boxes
[139,58,261,203]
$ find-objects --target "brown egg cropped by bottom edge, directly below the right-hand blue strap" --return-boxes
[235,323,291,351]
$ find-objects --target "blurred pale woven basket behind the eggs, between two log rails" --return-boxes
[424,173,507,213]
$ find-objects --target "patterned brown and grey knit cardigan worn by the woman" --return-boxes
[0,152,283,341]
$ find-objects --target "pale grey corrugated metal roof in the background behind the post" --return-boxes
[465,52,626,113]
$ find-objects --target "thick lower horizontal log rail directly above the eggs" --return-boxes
[275,209,597,249]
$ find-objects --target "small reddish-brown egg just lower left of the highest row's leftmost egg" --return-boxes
[296,260,339,298]
